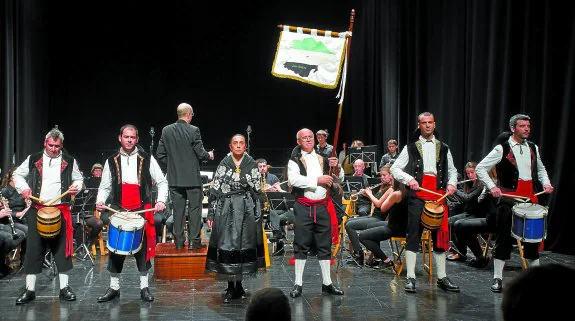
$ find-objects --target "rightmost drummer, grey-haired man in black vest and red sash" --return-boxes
[475,114,553,293]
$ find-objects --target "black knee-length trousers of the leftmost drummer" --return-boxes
[24,207,73,274]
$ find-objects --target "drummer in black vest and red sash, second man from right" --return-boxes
[391,112,459,293]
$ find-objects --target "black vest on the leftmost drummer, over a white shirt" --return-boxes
[28,151,74,203]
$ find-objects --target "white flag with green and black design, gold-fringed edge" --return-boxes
[272,28,346,89]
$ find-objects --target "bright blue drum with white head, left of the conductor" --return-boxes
[106,213,145,255]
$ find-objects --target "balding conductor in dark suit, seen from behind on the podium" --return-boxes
[156,103,214,250]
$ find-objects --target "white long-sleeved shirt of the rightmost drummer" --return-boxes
[475,136,551,190]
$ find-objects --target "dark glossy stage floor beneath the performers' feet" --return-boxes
[0,231,575,321]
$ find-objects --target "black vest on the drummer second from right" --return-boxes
[404,142,449,190]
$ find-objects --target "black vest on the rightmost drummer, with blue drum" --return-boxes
[495,140,539,191]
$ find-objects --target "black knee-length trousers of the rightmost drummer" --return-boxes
[493,198,541,261]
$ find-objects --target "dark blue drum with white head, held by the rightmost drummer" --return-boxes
[511,203,548,243]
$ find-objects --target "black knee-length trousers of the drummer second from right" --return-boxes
[405,196,445,253]
